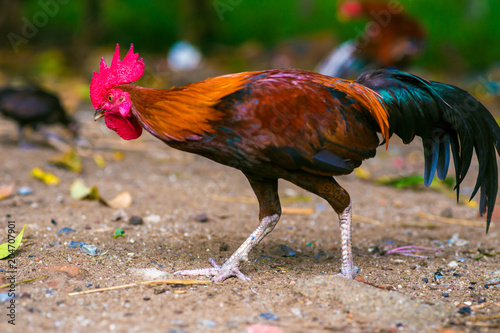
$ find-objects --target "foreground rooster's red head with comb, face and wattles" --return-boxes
[90,44,144,140]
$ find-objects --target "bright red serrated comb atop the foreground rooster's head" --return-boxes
[90,44,144,109]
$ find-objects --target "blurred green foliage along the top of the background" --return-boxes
[13,0,500,69]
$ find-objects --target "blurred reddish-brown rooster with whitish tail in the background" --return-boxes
[315,0,425,79]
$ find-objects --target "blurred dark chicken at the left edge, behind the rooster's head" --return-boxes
[0,85,78,141]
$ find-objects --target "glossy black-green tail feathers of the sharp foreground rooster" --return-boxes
[356,69,500,231]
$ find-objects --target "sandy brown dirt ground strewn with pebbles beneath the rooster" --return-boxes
[0,107,500,333]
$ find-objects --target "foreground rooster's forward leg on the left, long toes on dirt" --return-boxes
[175,175,281,282]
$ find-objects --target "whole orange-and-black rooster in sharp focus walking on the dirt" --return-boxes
[90,45,500,282]
